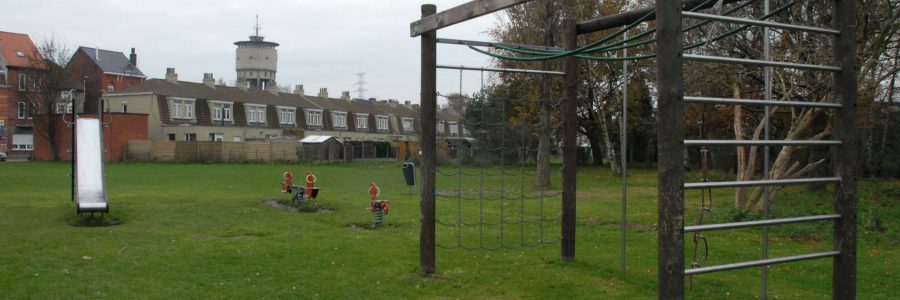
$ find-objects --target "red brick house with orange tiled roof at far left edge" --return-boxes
[0,31,42,158]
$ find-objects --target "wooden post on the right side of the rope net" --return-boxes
[561,16,578,261]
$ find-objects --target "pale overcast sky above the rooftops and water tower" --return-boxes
[0,0,512,103]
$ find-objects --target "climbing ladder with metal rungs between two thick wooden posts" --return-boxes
[656,0,858,299]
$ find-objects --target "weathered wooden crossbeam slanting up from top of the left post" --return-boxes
[409,0,531,37]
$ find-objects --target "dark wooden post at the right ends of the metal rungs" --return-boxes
[831,0,859,299]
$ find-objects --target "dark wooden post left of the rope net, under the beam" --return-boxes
[419,4,437,275]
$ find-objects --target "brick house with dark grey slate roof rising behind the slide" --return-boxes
[66,46,147,113]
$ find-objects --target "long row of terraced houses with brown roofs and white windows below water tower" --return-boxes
[108,68,468,159]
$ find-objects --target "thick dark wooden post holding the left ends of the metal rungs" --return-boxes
[656,0,684,299]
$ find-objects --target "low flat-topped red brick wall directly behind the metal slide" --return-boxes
[34,113,147,162]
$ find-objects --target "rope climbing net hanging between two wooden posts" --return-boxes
[435,88,562,250]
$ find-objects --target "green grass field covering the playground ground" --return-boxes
[0,162,900,299]
